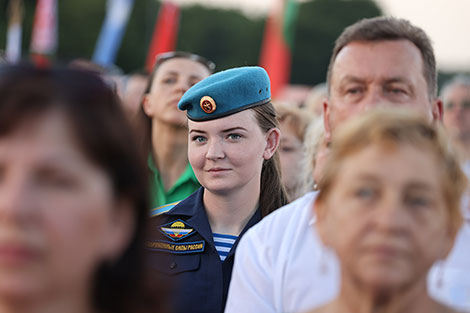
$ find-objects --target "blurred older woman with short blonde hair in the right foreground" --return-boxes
[311,110,466,313]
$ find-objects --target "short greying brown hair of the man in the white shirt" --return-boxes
[327,16,437,99]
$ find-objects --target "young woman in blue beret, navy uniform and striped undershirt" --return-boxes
[147,67,287,313]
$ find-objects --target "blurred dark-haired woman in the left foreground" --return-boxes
[0,66,162,313]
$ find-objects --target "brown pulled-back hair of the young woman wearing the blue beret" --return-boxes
[252,103,288,217]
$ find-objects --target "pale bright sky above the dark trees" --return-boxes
[173,0,470,72]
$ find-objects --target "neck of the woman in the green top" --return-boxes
[151,121,188,190]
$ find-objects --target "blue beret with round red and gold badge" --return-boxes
[178,66,271,121]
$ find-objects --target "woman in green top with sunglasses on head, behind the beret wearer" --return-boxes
[138,52,215,208]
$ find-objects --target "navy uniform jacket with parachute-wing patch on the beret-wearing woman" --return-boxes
[146,188,261,313]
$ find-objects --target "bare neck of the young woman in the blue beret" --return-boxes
[204,182,260,236]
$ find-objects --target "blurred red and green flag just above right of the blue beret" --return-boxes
[260,0,298,98]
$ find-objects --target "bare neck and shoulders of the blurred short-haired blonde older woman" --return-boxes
[325,276,451,313]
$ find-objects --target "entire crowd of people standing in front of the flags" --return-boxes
[0,17,470,313]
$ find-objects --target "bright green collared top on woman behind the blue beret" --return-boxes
[148,155,201,209]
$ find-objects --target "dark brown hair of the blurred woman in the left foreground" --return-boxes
[0,65,167,313]
